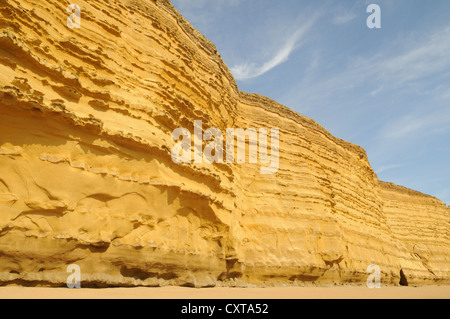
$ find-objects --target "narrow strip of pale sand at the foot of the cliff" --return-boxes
[0,286,450,300]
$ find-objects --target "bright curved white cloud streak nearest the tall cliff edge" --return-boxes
[231,18,316,80]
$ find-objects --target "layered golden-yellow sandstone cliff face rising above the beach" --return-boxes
[0,0,450,287]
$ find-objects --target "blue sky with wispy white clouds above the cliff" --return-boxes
[172,0,450,204]
